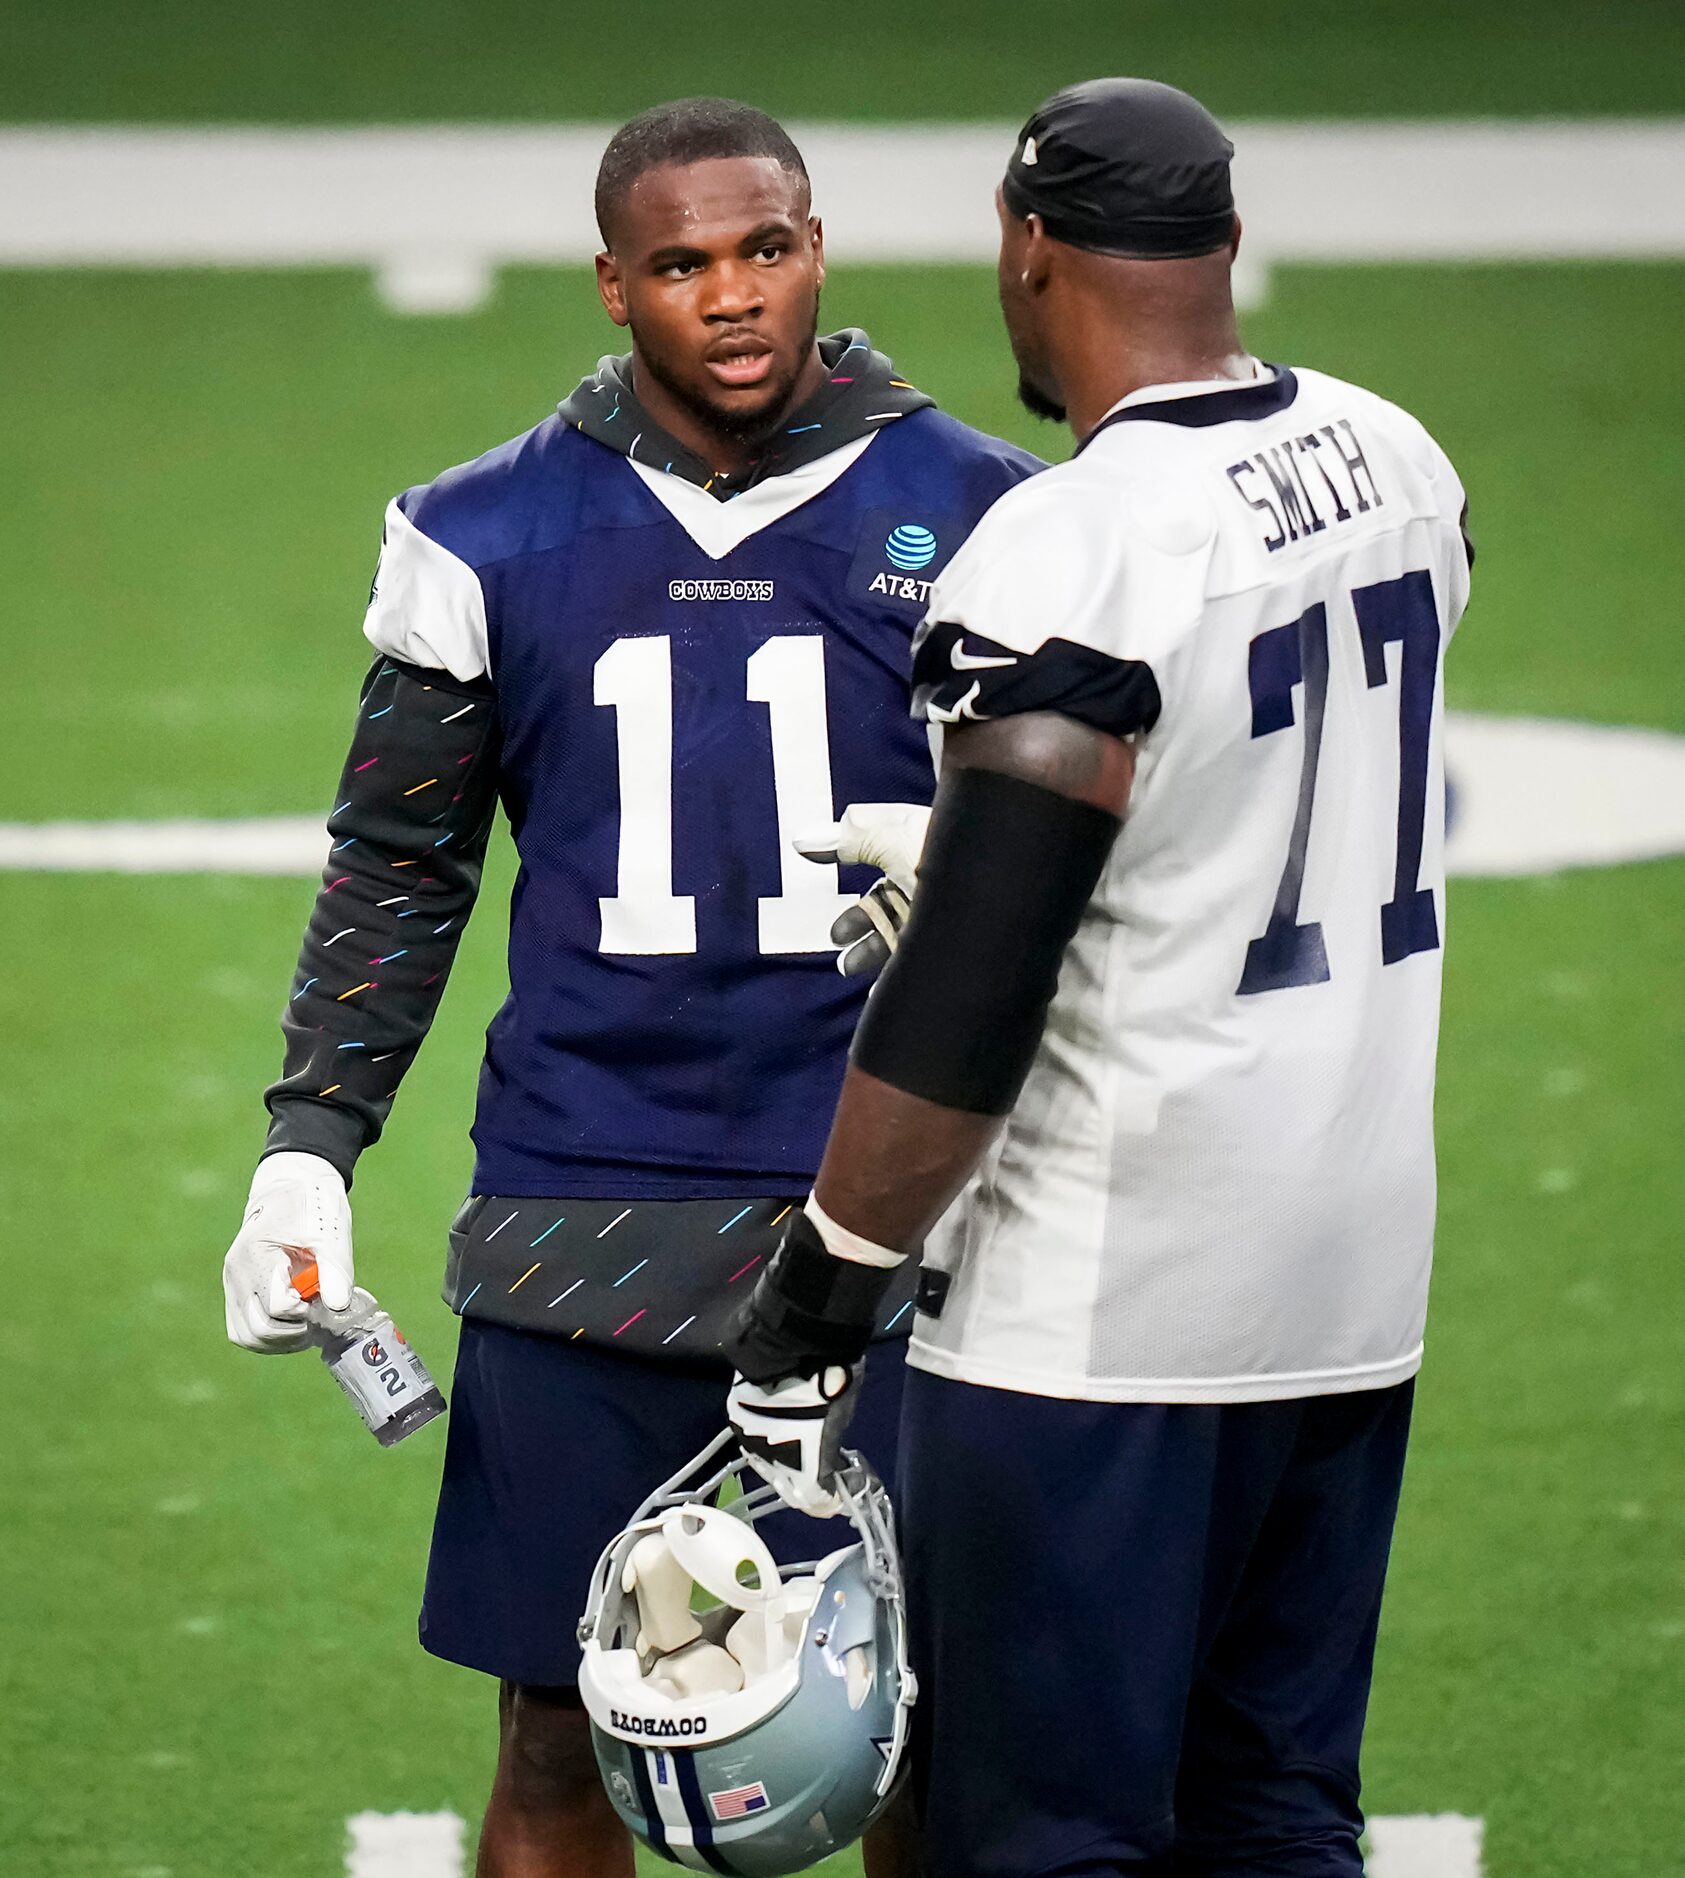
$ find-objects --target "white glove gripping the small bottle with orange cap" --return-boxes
[222,1153,355,1356]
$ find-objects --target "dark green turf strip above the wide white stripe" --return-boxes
[0,0,1685,124]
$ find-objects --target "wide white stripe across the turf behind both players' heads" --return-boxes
[0,118,1685,312]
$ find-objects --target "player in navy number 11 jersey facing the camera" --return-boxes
[224,100,1039,1878]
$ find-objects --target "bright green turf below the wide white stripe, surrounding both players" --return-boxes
[0,253,1685,1878]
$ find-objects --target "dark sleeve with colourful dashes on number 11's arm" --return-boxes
[263,657,500,1185]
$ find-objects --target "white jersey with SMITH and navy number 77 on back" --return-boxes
[911,368,1469,1403]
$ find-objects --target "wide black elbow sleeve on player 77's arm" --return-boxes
[853,770,1121,1116]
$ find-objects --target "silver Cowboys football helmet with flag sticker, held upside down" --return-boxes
[579,1429,917,1878]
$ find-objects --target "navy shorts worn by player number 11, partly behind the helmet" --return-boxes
[421,1318,905,1688]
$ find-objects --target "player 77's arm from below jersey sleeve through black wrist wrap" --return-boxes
[725,714,1135,1384]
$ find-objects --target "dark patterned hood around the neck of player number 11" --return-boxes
[556,327,935,501]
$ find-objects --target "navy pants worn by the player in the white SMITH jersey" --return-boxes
[900,1371,1413,1878]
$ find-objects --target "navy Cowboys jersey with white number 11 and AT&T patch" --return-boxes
[366,408,1039,1198]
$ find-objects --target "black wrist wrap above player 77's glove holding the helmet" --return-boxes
[723,1213,900,1382]
